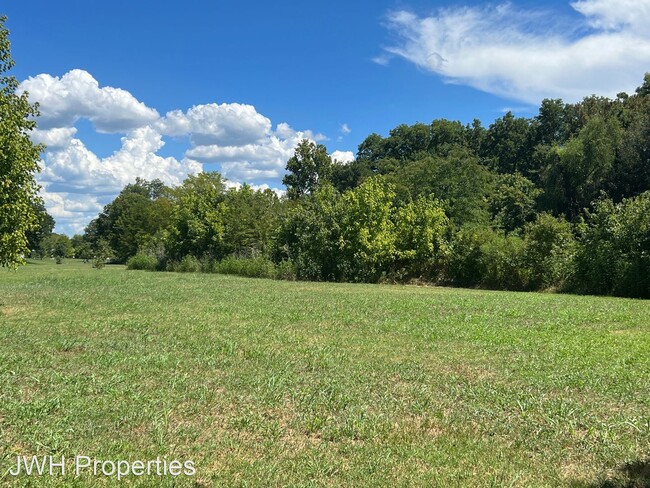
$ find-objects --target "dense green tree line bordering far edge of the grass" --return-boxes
[62,75,650,298]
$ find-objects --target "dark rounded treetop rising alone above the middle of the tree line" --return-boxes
[282,139,332,200]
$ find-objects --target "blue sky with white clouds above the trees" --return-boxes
[0,0,650,235]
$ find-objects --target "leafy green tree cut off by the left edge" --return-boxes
[0,16,44,268]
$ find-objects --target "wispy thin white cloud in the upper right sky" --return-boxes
[375,0,650,104]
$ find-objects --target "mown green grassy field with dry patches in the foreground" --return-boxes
[0,261,650,487]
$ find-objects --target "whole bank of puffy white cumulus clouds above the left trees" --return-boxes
[20,70,342,234]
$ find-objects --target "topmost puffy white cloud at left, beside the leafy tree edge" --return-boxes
[20,69,159,133]
